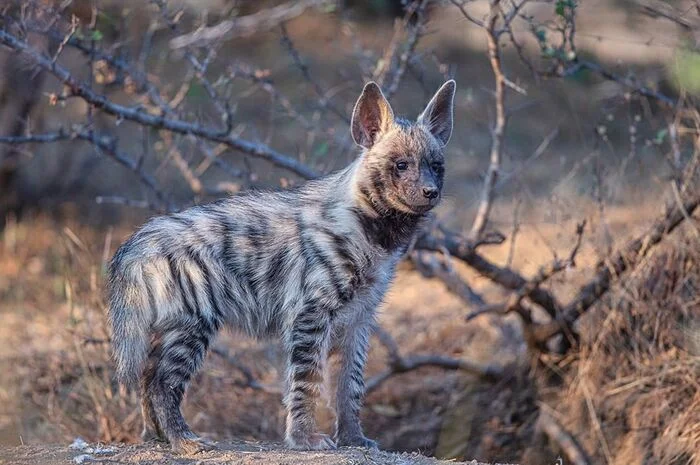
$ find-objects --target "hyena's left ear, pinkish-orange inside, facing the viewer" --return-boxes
[350,82,394,149]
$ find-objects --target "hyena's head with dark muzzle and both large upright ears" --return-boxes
[351,80,456,215]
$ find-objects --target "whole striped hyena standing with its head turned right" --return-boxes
[108,81,455,453]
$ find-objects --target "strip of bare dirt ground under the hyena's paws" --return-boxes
[0,442,500,465]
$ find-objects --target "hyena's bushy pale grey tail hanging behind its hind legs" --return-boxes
[108,256,155,387]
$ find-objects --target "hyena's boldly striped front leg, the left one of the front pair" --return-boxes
[285,305,335,450]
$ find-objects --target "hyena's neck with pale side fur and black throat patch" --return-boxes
[349,160,425,253]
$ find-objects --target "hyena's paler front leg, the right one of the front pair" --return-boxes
[336,324,378,449]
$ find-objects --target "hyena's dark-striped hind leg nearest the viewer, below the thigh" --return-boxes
[144,328,213,454]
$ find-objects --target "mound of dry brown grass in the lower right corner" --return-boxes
[557,232,700,465]
